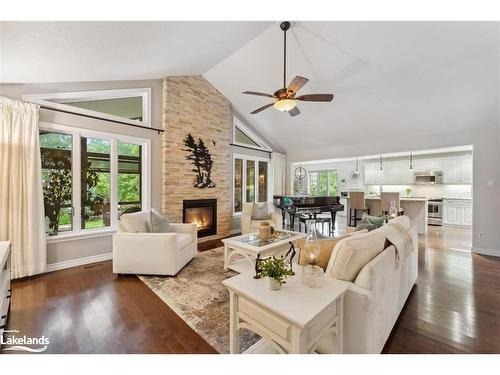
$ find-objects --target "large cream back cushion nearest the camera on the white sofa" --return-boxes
[330,231,385,281]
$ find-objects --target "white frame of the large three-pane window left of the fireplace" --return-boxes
[39,121,151,243]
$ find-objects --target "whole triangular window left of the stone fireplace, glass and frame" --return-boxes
[23,88,151,127]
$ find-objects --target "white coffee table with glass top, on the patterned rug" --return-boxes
[222,230,306,273]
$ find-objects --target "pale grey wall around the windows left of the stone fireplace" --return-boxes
[0,80,161,267]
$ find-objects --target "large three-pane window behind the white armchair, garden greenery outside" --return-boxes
[40,123,150,238]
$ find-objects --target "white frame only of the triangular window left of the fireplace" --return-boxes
[23,88,151,128]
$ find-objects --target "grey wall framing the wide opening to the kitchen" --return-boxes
[287,124,500,256]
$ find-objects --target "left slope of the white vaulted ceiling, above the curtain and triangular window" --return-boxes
[0,22,273,83]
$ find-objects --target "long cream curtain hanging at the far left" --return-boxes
[0,96,47,278]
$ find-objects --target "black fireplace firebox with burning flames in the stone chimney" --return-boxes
[182,199,217,238]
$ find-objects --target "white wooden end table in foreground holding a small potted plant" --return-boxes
[222,265,349,354]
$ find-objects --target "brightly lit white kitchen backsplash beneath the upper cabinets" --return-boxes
[366,185,472,198]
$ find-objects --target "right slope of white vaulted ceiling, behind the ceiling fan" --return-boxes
[205,22,500,153]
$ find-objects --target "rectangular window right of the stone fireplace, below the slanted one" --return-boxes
[233,155,270,214]
